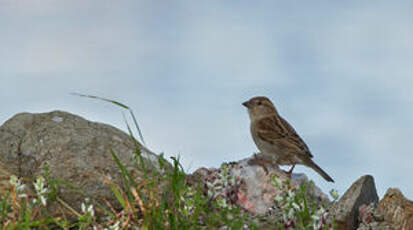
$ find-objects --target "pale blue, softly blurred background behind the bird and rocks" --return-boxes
[0,0,413,198]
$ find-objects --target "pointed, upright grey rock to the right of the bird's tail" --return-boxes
[332,175,379,230]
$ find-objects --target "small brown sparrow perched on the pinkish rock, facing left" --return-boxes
[242,97,334,182]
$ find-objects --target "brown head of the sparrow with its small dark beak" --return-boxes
[242,96,277,120]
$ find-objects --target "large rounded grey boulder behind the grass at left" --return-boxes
[0,111,164,217]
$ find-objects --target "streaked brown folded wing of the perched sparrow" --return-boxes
[257,116,313,157]
